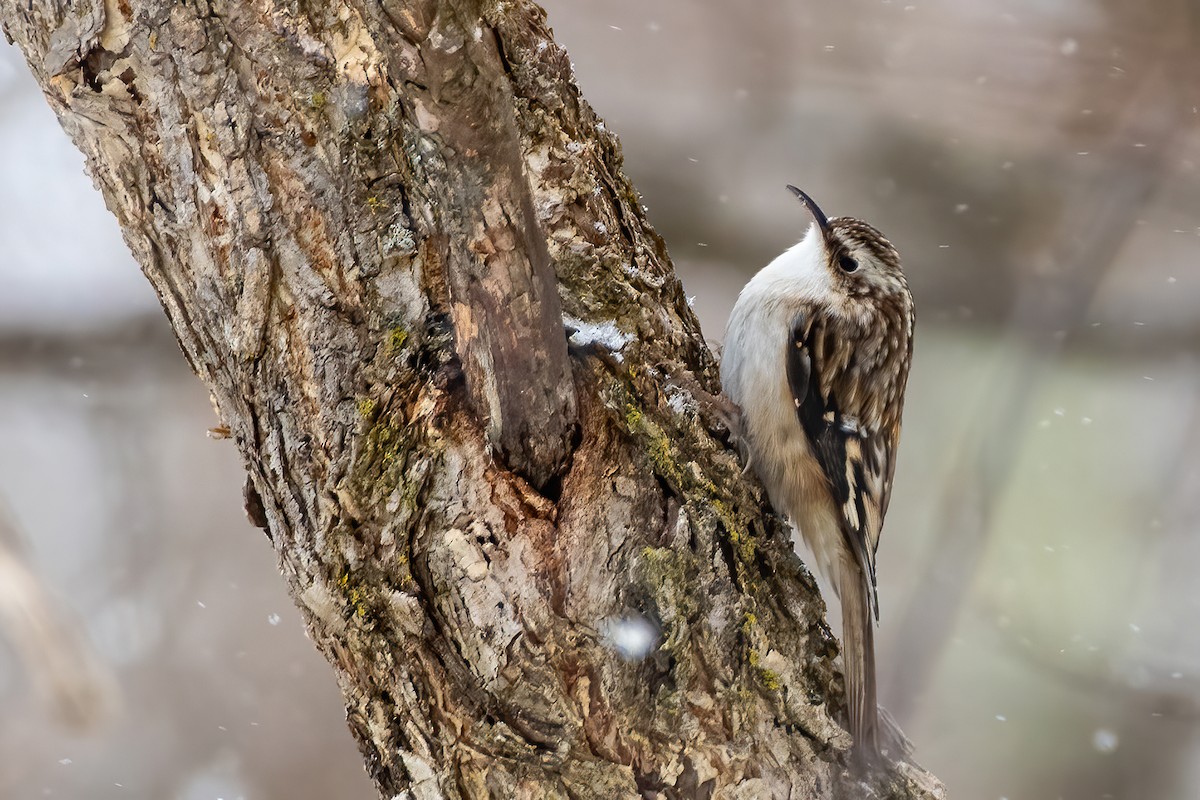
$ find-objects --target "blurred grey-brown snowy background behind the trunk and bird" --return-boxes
[0,0,1200,800]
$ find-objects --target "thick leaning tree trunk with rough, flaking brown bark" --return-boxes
[0,0,941,799]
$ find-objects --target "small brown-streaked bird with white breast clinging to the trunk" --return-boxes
[721,185,916,763]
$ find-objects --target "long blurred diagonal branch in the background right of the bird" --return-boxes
[887,34,1194,720]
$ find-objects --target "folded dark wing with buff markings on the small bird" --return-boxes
[787,314,900,619]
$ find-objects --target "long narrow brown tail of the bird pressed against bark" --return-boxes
[838,559,880,762]
